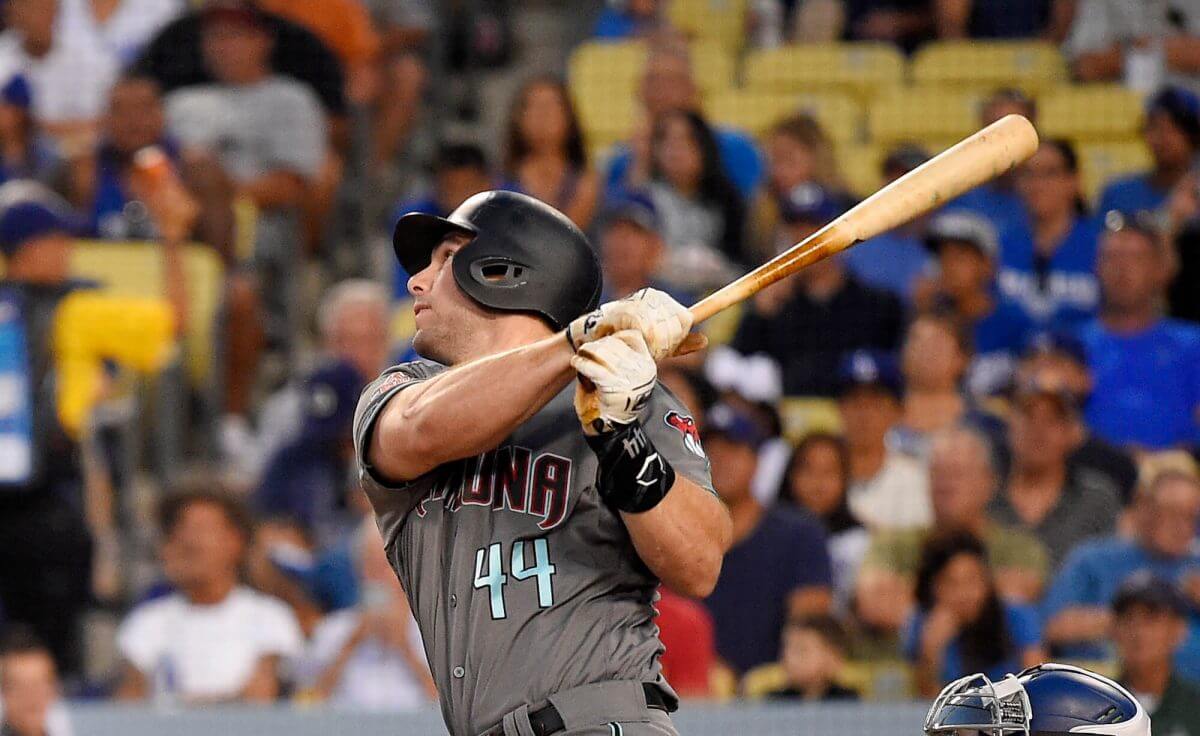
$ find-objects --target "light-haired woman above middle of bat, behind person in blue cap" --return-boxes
[752,113,842,261]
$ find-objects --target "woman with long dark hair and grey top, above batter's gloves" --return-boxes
[649,110,746,288]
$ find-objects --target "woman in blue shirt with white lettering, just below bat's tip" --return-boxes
[1000,140,1099,327]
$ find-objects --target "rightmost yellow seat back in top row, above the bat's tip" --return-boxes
[912,41,1068,94]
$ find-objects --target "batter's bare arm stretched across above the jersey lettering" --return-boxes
[370,334,575,480]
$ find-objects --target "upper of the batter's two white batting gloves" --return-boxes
[566,289,691,360]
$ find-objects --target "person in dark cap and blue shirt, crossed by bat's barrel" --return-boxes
[842,145,930,304]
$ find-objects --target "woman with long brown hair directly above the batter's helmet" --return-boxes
[504,77,600,229]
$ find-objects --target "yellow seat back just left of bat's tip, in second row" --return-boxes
[866,86,979,144]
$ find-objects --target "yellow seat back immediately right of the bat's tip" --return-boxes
[1038,84,1144,143]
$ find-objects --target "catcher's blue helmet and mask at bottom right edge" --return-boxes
[925,664,1150,736]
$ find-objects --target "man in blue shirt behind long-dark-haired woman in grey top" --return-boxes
[605,43,763,197]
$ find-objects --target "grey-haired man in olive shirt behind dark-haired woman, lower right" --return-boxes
[857,426,1048,635]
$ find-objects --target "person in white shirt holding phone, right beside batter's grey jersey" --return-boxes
[298,519,437,711]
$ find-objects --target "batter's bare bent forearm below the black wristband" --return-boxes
[622,475,732,598]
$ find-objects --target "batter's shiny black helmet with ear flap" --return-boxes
[391,191,601,329]
